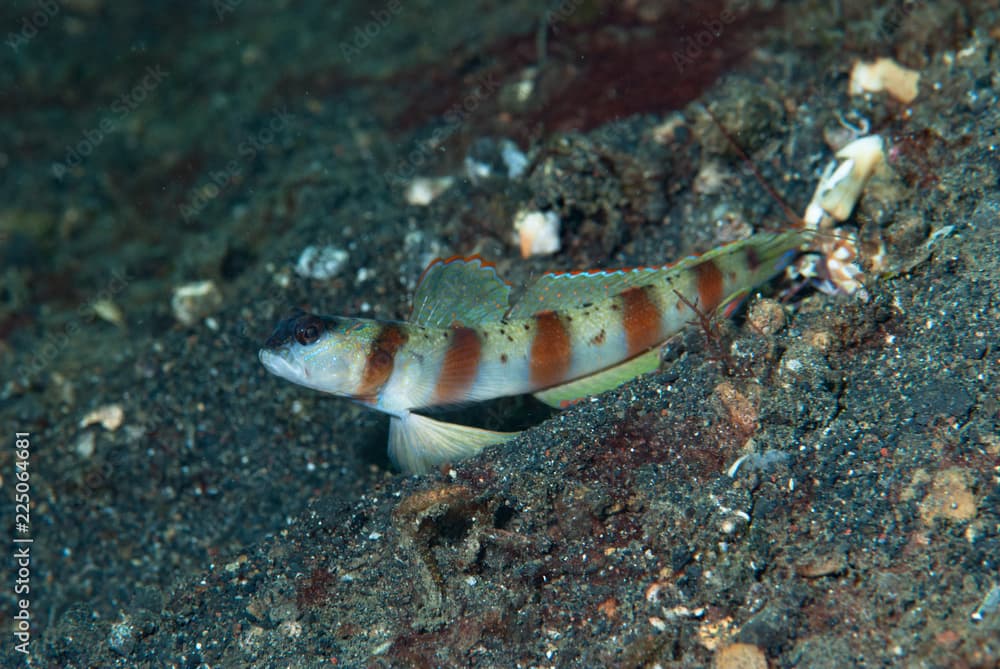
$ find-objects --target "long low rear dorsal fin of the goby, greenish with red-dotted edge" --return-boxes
[507,267,664,319]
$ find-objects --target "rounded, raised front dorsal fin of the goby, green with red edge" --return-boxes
[410,256,510,327]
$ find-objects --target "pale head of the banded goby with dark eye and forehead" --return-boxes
[258,310,373,397]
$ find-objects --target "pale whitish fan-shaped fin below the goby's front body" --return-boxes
[389,413,518,474]
